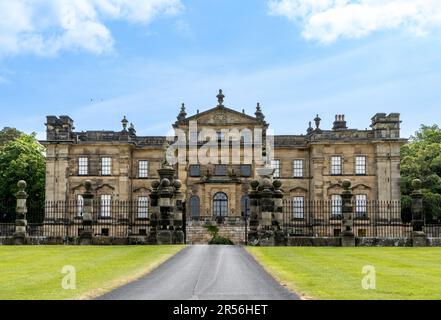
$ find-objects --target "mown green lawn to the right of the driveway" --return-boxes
[248,247,441,300]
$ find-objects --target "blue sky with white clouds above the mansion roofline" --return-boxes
[0,0,441,138]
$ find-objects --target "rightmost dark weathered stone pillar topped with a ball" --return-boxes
[411,179,427,247]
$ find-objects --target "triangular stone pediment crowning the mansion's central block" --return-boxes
[177,106,265,125]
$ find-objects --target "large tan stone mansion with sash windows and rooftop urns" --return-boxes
[41,91,406,217]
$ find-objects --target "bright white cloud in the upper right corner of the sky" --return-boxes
[268,0,441,43]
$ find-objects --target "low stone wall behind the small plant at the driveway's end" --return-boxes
[187,224,245,244]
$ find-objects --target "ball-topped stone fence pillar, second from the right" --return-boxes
[341,180,355,247]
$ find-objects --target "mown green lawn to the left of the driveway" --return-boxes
[0,246,184,300]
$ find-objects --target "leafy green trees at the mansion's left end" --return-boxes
[0,128,45,222]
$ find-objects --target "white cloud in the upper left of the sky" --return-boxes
[0,0,183,55]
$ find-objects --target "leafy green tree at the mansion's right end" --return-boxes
[401,125,441,220]
